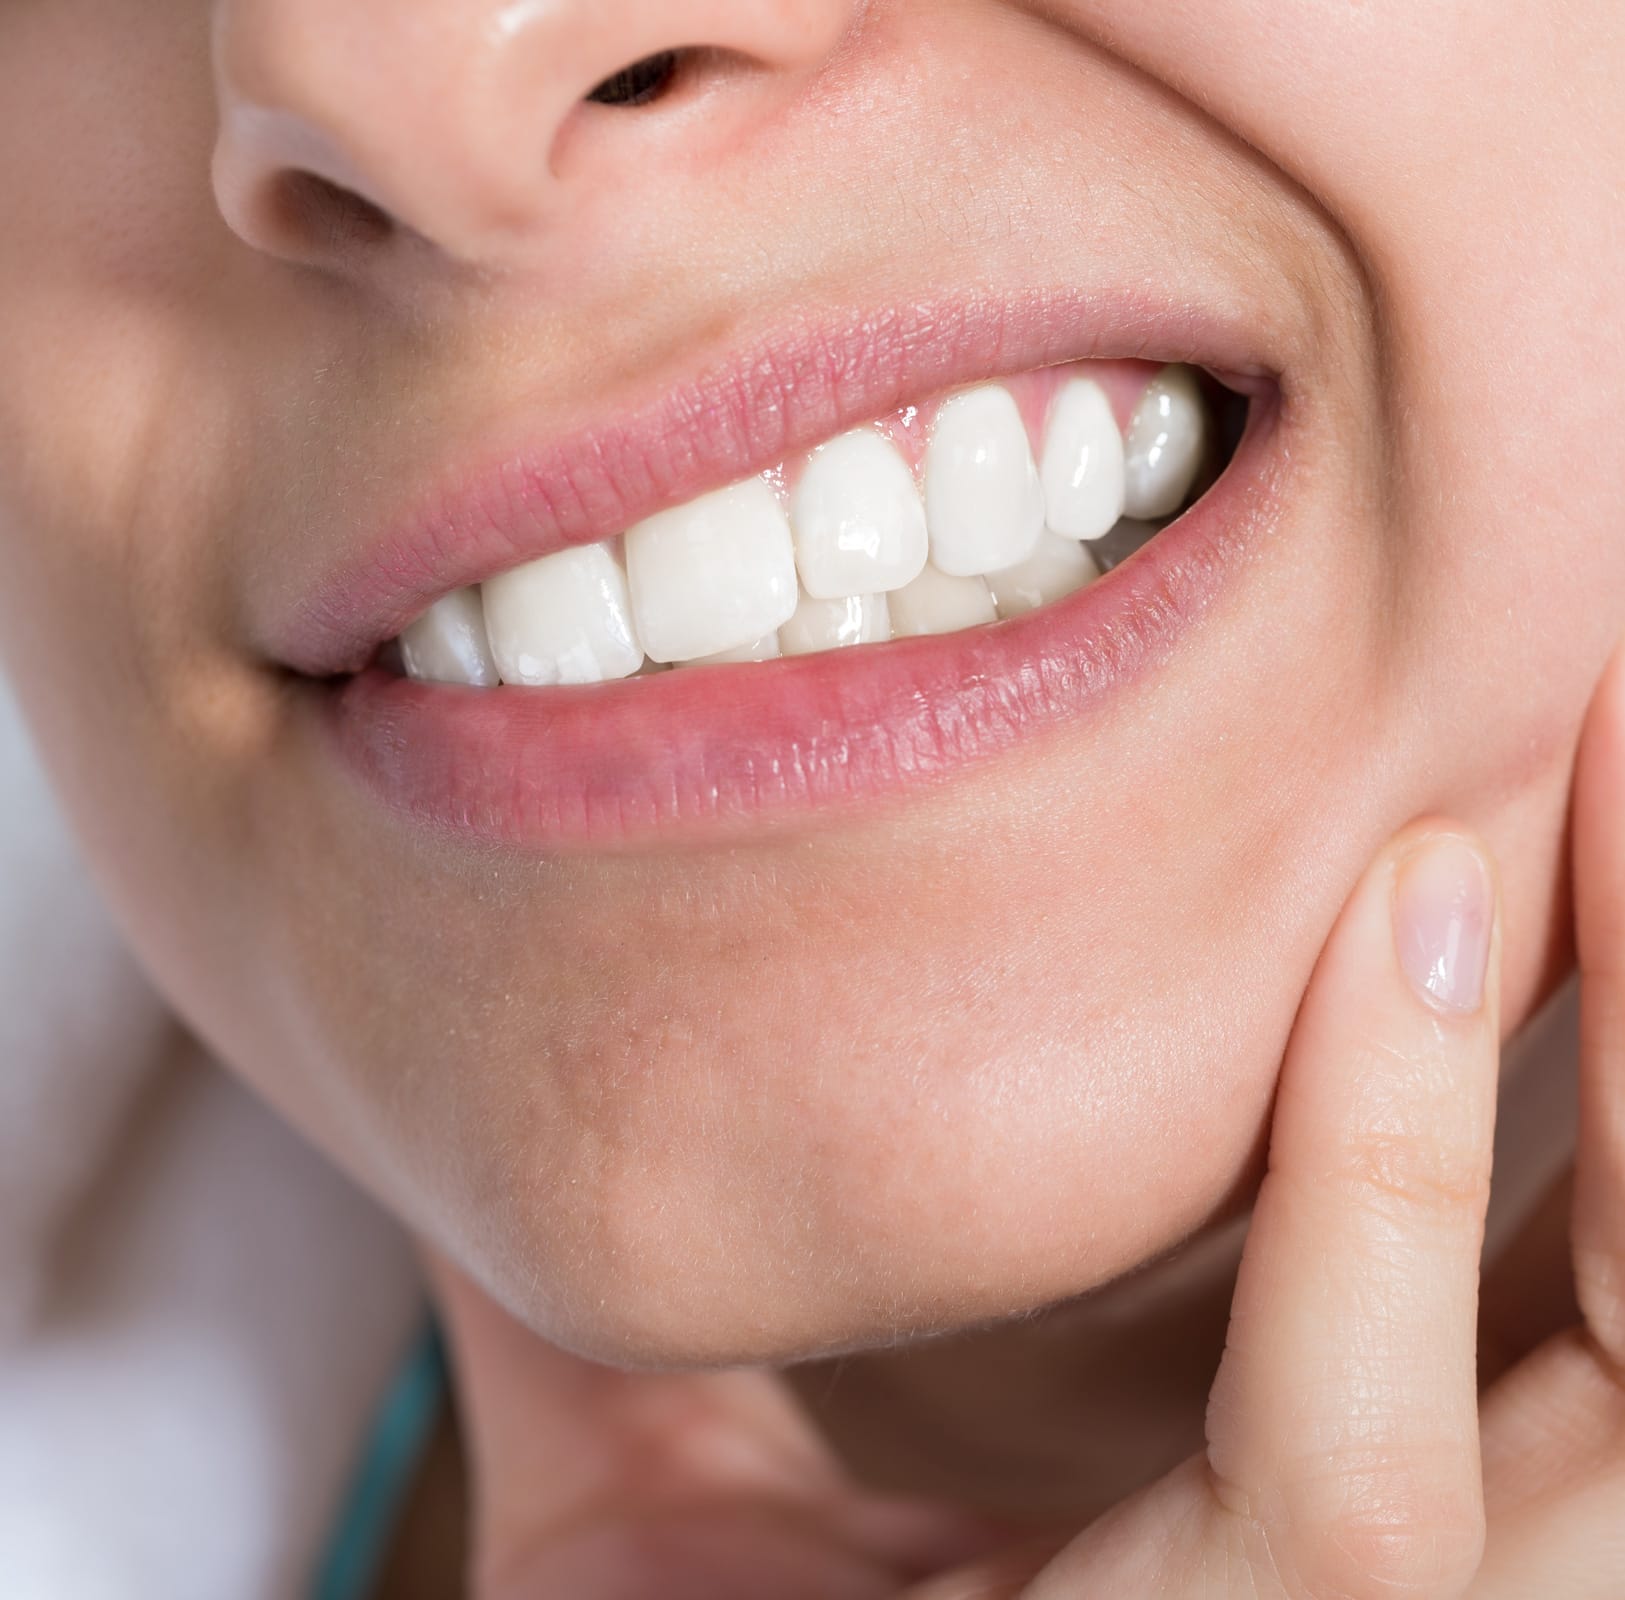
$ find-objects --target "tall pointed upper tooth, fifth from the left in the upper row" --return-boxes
[925,383,1043,578]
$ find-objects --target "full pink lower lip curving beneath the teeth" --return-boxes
[317,400,1279,850]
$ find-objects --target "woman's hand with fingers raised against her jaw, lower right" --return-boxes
[907,651,1625,1600]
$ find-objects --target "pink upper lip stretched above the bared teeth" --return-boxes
[267,292,1279,677]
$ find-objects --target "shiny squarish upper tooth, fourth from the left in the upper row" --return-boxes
[790,429,928,599]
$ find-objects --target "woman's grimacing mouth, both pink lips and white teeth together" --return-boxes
[281,297,1282,848]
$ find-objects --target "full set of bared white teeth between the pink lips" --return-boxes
[384,362,1219,687]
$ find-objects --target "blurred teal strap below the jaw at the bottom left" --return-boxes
[310,1319,447,1600]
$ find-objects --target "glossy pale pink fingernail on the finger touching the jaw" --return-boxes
[1394,833,1495,1014]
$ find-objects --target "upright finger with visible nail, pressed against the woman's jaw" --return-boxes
[1207,825,1500,1595]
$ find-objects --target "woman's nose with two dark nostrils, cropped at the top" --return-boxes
[213,0,860,266]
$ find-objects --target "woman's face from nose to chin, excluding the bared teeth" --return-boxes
[0,0,1625,1364]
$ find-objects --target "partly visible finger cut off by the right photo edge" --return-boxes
[1573,650,1625,1377]
